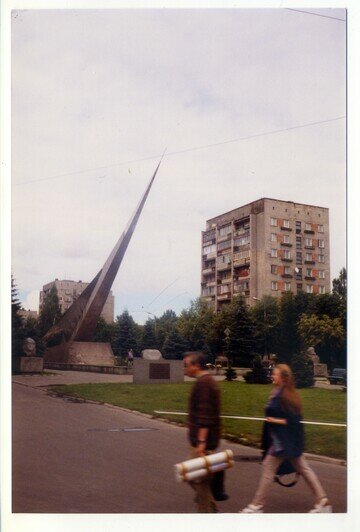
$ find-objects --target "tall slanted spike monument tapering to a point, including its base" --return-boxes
[43,160,165,366]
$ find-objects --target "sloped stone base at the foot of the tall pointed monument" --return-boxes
[44,342,115,366]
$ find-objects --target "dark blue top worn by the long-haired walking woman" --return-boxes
[262,389,304,458]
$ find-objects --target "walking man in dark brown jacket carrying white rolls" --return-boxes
[184,352,221,513]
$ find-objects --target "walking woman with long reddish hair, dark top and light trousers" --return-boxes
[240,364,332,514]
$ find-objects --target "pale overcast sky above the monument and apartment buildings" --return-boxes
[12,8,346,323]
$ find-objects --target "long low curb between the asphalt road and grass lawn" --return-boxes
[38,383,347,466]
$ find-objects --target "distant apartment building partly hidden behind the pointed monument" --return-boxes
[39,279,114,323]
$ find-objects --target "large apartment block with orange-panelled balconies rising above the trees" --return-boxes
[201,198,330,311]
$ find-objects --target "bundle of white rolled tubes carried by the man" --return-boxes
[174,449,234,482]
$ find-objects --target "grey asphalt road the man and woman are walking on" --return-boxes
[12,383,346,513]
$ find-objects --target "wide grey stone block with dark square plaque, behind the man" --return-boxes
[133,358,184,384]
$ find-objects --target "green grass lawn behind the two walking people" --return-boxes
[51,381,347,459]
